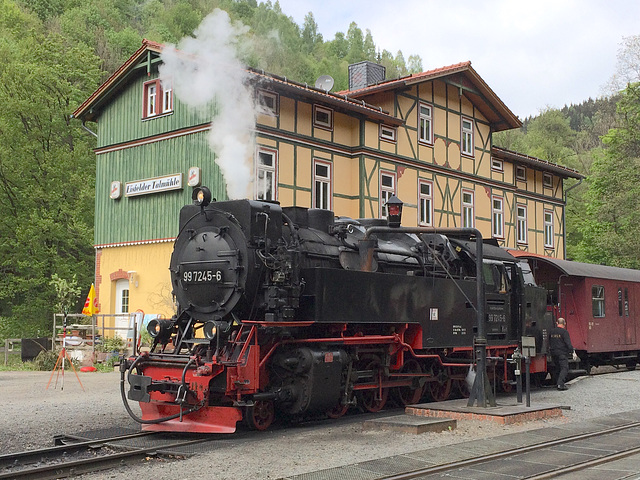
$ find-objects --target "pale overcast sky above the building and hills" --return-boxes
[272,0,640,119]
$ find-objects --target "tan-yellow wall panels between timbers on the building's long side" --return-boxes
[252,79,562,256]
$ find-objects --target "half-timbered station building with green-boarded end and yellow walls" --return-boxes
[74,41,582,316]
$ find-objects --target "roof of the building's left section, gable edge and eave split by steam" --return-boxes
[73,39,404,126]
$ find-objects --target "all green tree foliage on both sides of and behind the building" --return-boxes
[0,0,640,349]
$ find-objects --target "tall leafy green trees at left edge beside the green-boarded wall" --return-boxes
[0,1,99,337]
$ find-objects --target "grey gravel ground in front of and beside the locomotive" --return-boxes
[0,369,640,480]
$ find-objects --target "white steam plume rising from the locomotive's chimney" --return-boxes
[160,9,256,199]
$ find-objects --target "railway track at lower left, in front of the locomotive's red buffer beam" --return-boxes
[0,432,210,480]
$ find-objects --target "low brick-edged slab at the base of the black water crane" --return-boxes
[405,398,569,425]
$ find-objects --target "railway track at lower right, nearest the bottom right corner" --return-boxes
[377,422,640,480]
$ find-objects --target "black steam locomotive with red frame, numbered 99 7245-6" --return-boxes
[121,187,546,433]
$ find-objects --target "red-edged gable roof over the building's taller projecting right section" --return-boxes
[338,62,522,132]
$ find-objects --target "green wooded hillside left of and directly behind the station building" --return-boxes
[0,0,420,338]
